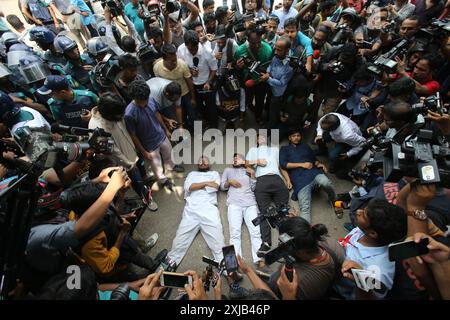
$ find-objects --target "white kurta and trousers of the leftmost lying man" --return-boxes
[168,171,225,265]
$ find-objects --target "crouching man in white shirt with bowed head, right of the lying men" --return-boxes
[314,113,366,173]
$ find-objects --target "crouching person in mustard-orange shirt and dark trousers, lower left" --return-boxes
[61,182,167,283]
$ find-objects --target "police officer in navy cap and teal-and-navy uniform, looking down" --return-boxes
[38,75,98,128]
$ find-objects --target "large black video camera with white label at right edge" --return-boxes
[368,129,450,188]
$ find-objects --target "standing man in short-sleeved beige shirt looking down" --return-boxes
[153,44,196,130]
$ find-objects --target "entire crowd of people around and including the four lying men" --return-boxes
[0,0,450,300]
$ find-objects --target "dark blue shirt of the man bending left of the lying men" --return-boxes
[125,98,166,152]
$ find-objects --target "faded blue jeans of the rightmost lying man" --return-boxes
[298,173,336,222]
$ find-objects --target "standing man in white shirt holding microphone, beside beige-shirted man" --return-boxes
[177,30,217,128]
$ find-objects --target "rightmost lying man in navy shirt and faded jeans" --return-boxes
[280,129,336,222]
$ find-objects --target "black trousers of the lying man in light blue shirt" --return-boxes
[255,174,289,246]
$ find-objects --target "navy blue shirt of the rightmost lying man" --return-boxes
[280,142,323,200]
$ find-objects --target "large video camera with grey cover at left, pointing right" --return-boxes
[14,124,114,169]
